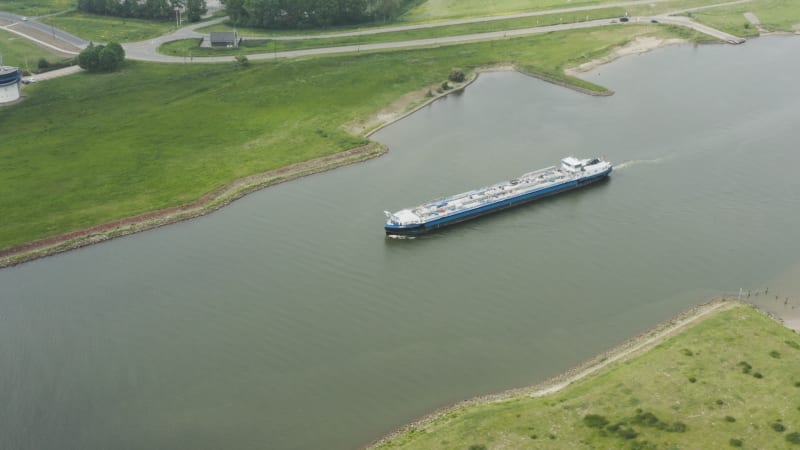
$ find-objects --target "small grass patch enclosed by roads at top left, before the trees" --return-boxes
[41,11,175,42]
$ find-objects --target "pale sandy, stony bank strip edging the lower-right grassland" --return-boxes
[362,297,785,450]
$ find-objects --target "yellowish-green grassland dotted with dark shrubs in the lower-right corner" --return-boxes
[380,305,800,449]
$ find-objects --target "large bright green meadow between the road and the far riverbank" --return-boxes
[0,26,684,253]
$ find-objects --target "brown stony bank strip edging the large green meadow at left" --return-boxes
[0,142,388,269]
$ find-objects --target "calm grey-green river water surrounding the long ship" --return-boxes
[0,37,800,450]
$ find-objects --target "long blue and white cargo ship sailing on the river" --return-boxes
[383,156,612,236]
